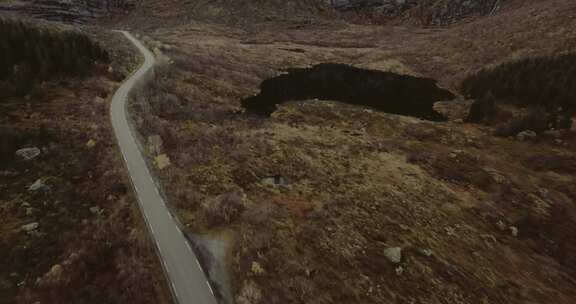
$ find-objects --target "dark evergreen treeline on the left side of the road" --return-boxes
[0,19,108,95]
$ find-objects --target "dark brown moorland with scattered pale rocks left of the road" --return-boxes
[0,17,170,304]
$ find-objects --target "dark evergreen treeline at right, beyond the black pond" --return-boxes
[461,54,576,115]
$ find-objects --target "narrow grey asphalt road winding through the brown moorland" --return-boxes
[110,31,217,304]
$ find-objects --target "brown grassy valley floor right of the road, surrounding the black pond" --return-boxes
[112,1,576,303]
